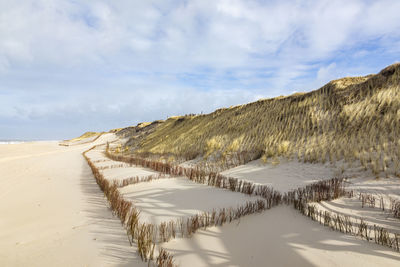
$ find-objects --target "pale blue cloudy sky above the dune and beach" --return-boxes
[0,0,400,140]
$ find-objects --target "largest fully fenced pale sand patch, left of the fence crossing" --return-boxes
[120,178,262,224]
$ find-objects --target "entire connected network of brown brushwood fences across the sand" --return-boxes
[83,142,400,264]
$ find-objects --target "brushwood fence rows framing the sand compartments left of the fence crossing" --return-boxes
[83,145,282,266]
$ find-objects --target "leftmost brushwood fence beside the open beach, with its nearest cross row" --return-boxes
[83,146,270,266]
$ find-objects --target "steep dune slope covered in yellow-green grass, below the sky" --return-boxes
[119,64,400,175]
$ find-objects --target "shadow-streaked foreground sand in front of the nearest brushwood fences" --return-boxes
[163,206,400,267]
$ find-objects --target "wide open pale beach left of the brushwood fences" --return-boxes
[0,142,143,266]
